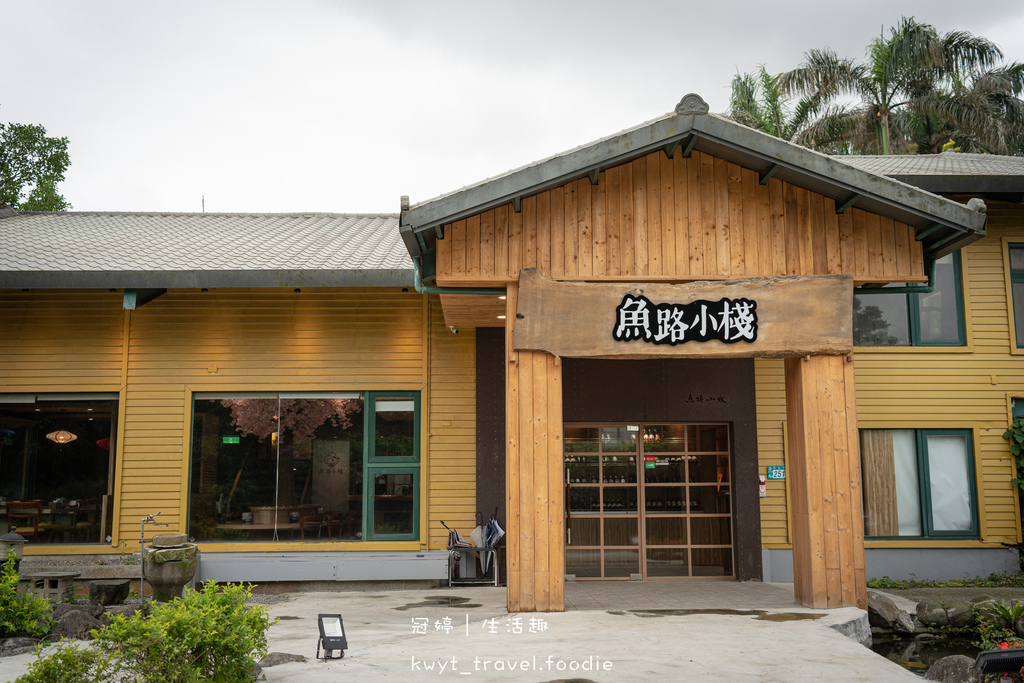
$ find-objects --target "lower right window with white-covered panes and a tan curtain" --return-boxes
[860,429,978,538]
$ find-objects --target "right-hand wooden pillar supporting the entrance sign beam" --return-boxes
[785,355,867,609]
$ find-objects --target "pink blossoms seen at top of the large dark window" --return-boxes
[220,398,362,451]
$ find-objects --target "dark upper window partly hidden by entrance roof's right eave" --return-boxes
[853,253,965,346]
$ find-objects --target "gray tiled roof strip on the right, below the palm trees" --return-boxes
[833,152,1024,176]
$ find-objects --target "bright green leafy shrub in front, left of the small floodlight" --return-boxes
[95,582,270,683]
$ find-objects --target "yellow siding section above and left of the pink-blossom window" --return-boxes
[120,289,423,538]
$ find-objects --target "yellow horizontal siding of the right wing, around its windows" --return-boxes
[755,202,1024,547]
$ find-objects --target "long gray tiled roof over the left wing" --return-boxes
[0,210,412,287]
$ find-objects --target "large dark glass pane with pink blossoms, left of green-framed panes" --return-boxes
[188,397,364,542]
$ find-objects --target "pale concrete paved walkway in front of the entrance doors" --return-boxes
[0,582,920,683]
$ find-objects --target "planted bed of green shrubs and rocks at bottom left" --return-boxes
[0,557,281,683]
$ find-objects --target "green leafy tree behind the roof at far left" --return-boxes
[0,123,72,211]
